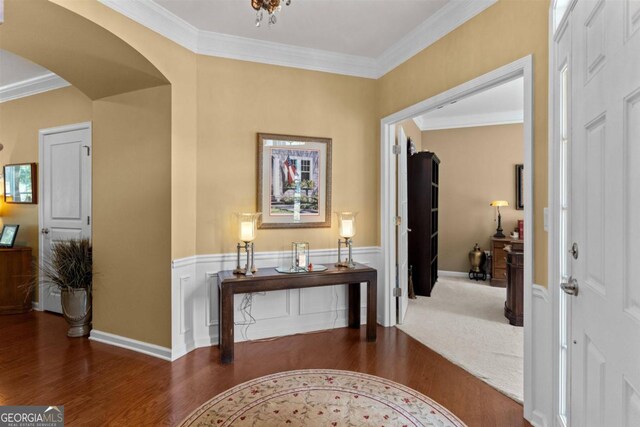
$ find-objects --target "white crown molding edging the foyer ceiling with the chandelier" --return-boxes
[98,0,497,79]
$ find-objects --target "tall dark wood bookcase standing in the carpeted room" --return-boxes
[407,151,440,296]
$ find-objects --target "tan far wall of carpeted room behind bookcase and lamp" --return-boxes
[422,124,524,272]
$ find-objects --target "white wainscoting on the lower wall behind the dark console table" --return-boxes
[171,247,381,360]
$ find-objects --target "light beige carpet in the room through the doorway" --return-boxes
[398,277,524,403]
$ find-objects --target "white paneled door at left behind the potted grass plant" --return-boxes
[40,123,92,313]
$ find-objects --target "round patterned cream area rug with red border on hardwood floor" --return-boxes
[181,369,464,427]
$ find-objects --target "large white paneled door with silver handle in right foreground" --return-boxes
[563,0,640,427]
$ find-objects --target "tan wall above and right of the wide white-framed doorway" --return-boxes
[377,0,549,285]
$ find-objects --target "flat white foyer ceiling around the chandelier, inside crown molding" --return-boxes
[153,0,451,58]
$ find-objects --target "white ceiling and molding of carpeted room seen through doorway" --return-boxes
[414,78,524,130]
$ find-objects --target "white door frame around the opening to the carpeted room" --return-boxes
[380,55,533,419]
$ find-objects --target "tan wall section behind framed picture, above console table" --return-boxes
[196,56,378,254]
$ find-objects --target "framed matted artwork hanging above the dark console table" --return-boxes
[258,133,331,229]
